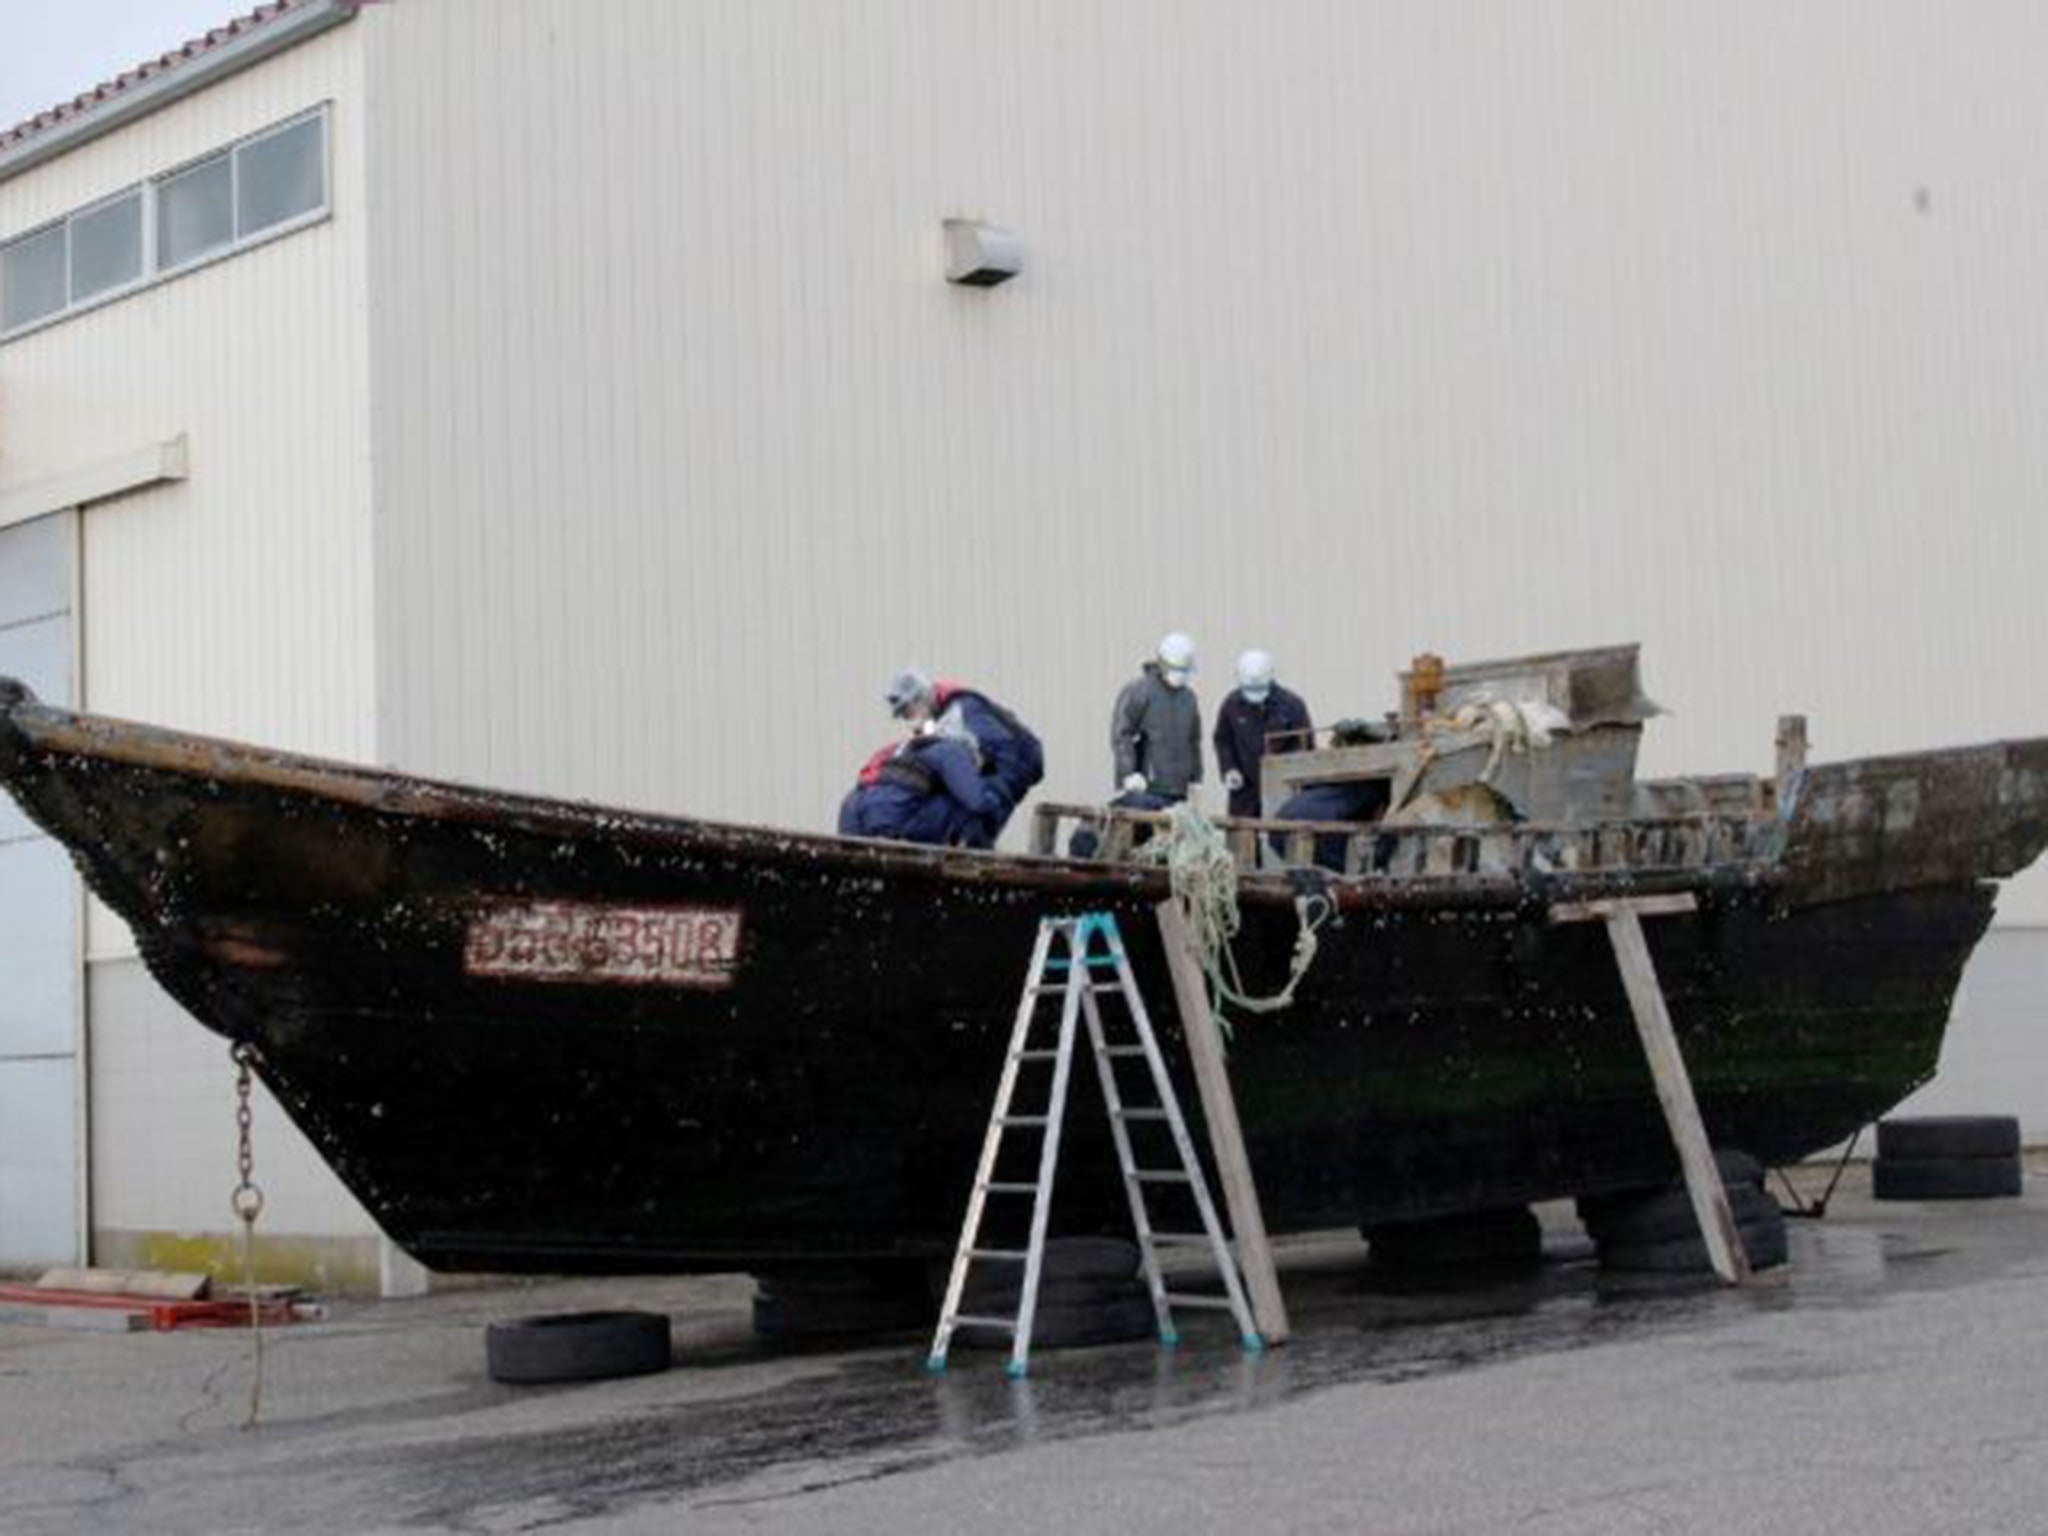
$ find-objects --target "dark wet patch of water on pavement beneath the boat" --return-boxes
[383,1221,2042,1524]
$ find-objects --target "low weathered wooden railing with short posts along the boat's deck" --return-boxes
[1032,805,1780,879]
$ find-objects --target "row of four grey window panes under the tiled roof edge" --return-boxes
[0,106,328,338]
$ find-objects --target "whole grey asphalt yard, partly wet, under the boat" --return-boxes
[0,1169,2048,1536]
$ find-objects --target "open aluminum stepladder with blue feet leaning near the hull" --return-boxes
[926,911,1264,1376]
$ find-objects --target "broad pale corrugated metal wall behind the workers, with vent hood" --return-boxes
[365,0,2048,922]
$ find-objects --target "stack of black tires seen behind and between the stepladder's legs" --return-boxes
[952,1237,1159,1350]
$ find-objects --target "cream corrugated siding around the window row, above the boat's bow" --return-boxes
[0,27,375,758]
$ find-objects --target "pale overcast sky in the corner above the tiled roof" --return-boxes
[0,0,241,129]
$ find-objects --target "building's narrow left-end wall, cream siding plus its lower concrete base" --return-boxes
[0,27,377,1274]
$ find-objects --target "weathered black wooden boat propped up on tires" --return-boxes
[0,647,2048,1272]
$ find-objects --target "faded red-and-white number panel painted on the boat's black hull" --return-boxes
[463,901,739,987]
